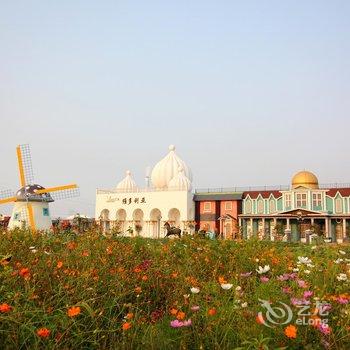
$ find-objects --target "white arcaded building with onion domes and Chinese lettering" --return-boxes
[96,145,195,238]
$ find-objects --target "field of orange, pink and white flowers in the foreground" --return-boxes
[0,231,350,349]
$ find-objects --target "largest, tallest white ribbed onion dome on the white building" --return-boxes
[151,145,192,189]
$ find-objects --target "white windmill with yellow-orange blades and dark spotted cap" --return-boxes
[0,145,79,231]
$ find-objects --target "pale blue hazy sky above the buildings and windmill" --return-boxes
[0,0,350,215]
